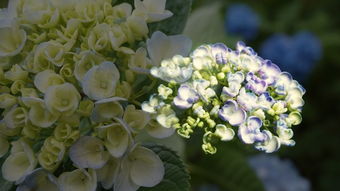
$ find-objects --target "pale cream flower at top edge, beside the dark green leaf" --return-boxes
[133,0,173,23]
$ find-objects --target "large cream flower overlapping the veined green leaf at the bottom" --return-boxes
[114,145,165,191]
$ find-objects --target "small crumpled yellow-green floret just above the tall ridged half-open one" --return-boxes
[53,123,80,147]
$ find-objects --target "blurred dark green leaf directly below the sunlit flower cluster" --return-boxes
[189,144,264,191]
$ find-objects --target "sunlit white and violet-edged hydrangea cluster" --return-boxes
[142,42,305,153]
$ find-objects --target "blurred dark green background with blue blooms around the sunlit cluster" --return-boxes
[0,0,340,191]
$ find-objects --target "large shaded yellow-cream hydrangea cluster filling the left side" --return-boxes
[0,0,191,191]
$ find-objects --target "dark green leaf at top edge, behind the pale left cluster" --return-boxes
[149,0,192,35]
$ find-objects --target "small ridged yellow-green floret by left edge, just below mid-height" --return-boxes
[4,107,28,129]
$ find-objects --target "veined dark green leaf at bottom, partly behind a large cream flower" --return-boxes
[138,144,190,191]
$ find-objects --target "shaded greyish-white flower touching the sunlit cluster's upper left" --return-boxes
[146,31,192,66]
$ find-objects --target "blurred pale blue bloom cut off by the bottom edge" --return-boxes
[248,154,310,191]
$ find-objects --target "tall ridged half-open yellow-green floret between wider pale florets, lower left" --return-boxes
[38,137,66,172]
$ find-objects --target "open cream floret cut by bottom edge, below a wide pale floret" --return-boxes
[58,169,97,191]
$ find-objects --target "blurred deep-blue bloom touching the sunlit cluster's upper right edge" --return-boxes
[260,32,322,81]
